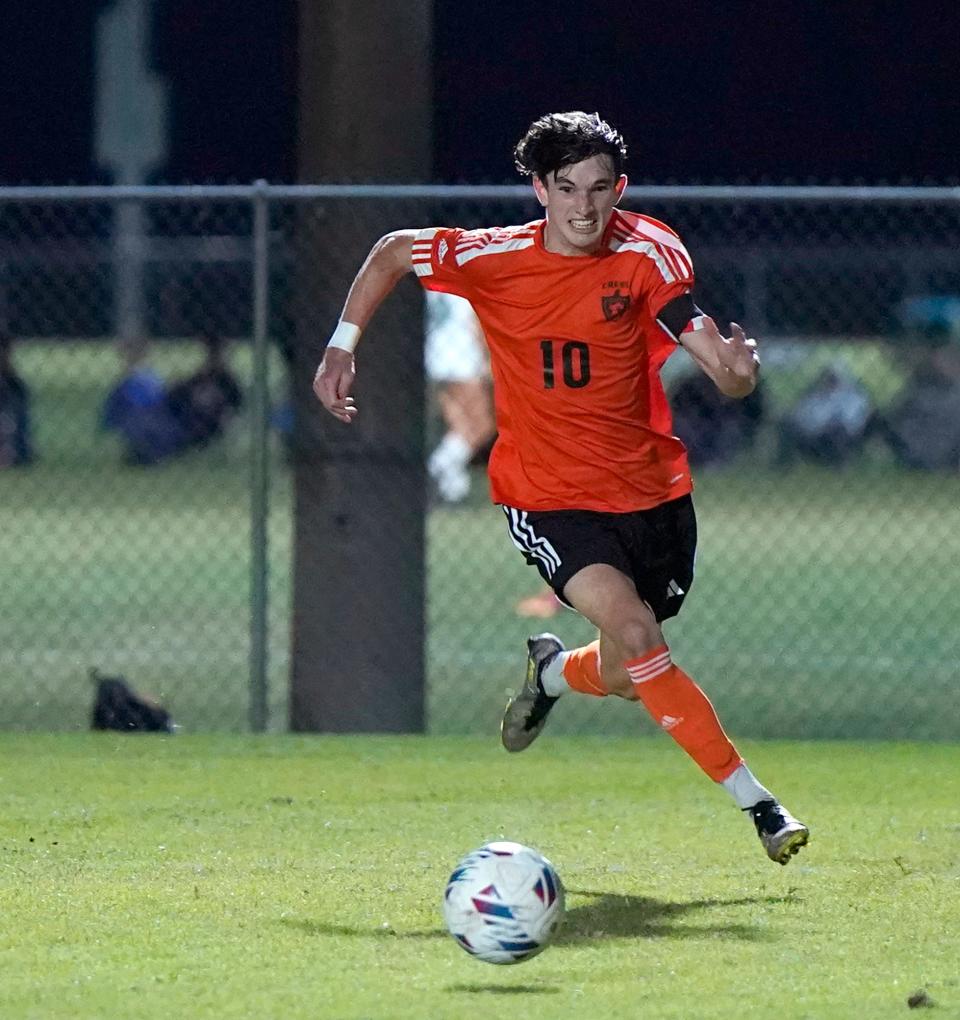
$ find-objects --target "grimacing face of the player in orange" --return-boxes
[534,156,626,255]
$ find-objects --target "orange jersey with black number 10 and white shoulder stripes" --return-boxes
[413,209,694,512]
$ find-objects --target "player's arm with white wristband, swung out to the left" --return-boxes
[313,231,417,424]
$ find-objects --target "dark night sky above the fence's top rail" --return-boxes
[0,0,960,184]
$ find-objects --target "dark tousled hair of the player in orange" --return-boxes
[513,110,626,181]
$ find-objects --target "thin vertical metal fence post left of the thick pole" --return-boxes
[250,181,269,733]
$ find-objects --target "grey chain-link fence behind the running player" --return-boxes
[0,186,960,740]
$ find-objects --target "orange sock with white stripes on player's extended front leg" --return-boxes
[624,645,743,782]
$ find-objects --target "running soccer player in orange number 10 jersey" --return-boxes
[313,111,809,864]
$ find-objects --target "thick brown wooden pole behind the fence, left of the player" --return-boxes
[290,0,433,732]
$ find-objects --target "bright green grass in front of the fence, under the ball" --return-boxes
[0,730,960,1020]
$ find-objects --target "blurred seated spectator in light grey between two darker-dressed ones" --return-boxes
[776,364,873,467]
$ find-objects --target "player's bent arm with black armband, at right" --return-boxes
[657,293,760,397]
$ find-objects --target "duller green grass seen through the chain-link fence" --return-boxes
[0,344,960,741]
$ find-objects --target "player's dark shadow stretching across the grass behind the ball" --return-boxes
[280,889,793,946]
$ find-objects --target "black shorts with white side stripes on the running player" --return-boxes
[502,496,697,620]
